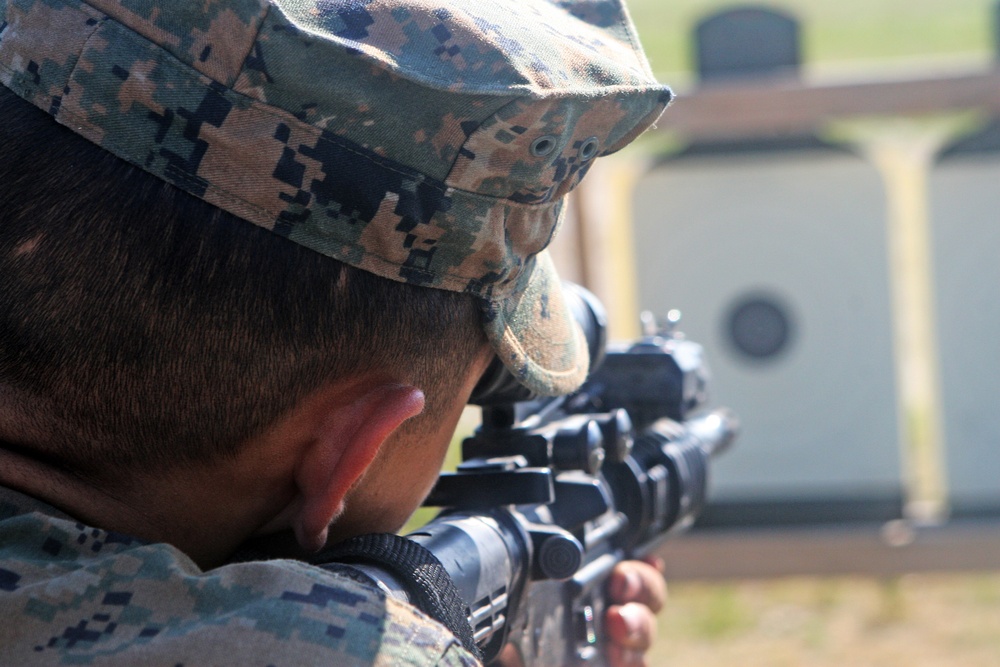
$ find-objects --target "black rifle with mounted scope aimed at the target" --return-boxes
[332,285,737,667]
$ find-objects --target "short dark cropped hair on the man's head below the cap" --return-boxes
[0,86,485,475]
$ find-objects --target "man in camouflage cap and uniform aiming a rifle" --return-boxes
[0,0,669,665]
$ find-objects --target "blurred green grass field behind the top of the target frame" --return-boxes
[628,0,995,82]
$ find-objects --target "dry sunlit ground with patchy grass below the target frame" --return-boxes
[650,573,1000,667]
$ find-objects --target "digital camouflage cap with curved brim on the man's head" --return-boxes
[0,0,670,394]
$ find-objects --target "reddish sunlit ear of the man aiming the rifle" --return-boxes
[293,384,424,552]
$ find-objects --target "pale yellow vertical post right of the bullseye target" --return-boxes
[832,114,970,524]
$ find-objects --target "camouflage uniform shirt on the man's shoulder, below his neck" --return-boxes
[0,488,478,667]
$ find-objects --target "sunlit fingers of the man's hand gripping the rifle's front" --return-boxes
[604,558,667,667]
